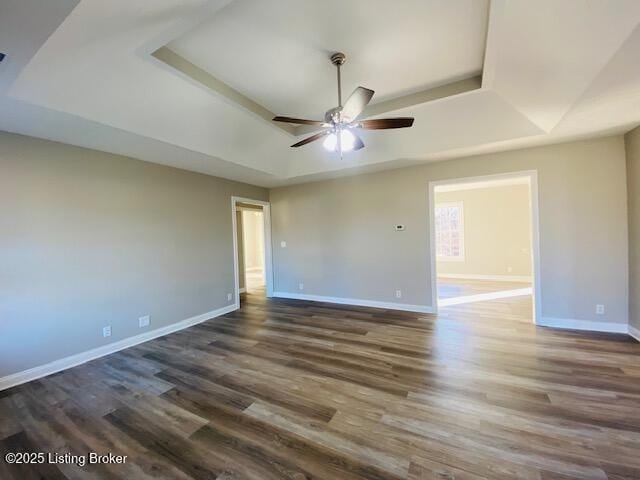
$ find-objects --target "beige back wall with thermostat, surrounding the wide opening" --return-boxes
[270,136,628,324]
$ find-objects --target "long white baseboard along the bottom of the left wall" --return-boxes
[0,303,239,391]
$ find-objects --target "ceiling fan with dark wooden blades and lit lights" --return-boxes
[273,52,413,156]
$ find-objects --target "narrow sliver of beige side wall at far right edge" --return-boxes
[624,127,640,330]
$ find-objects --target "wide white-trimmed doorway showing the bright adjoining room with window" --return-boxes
[429,172,540,323]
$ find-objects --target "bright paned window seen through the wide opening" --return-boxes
[436,202,464,261]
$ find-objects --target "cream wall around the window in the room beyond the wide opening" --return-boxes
[434,185,531,277]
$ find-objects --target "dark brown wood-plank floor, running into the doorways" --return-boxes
[0,295,640,480]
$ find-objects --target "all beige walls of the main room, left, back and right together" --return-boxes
[0,130,640,377]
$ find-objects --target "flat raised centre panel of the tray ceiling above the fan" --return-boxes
[168,0,489,118]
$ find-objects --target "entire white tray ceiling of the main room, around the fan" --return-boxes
[0,0,640,186]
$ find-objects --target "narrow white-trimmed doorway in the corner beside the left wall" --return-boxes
[231,197,273,307]
